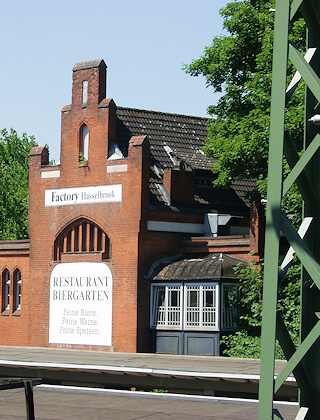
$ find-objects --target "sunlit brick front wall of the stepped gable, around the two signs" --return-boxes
[25,63,149,352]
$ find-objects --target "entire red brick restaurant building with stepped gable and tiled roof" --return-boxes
[0,60,261,354]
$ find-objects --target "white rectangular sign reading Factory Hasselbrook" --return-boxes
[45,184,122,206]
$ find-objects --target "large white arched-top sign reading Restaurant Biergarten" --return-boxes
[49,262,112,346]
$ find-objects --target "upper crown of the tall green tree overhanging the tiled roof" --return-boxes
[184,0,305,194]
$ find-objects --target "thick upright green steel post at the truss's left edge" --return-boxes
[259,0,290,420]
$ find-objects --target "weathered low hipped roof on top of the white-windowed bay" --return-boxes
[152,254,245,281]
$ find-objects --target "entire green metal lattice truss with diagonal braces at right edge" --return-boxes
[259,0,320,420]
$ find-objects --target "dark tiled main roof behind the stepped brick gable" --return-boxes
[117,107,256,212]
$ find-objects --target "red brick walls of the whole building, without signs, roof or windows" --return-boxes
[0,60,261,352]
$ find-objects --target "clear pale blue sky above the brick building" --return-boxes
[0,0,230,162]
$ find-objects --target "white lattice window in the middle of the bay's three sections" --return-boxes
[183,283,219,331]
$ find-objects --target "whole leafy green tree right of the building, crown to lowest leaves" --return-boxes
[183,0,306,358]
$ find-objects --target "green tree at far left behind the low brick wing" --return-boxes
[0,129,37,240]
